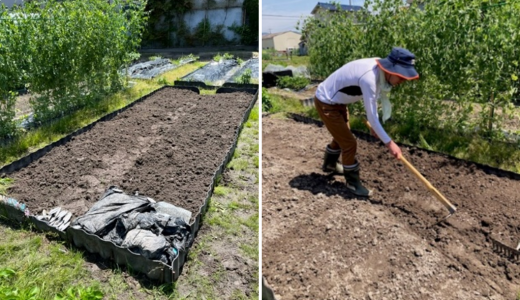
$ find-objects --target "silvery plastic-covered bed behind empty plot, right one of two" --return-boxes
[175,59,240,88]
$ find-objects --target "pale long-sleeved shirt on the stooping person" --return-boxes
[316,57,391,144]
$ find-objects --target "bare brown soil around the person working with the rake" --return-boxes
[261,116,520,299]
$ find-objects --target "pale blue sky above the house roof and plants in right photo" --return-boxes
[261,0,364,33]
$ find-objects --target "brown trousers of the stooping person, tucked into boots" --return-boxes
[314,97,357,166]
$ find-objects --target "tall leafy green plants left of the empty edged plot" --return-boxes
[0,0,146,132]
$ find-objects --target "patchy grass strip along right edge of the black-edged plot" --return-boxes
[174,102,260,300]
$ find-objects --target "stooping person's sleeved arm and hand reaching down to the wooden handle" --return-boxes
[360,76,402,159]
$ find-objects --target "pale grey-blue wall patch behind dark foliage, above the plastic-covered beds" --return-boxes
[184,7,242,40]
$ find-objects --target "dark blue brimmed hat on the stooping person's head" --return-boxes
[376,47,419,80]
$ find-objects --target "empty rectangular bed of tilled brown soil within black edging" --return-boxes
[8,88,253,223]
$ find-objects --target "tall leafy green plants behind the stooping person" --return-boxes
[302,0,520,141]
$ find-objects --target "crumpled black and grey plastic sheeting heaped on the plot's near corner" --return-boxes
[72,187,193,264]
